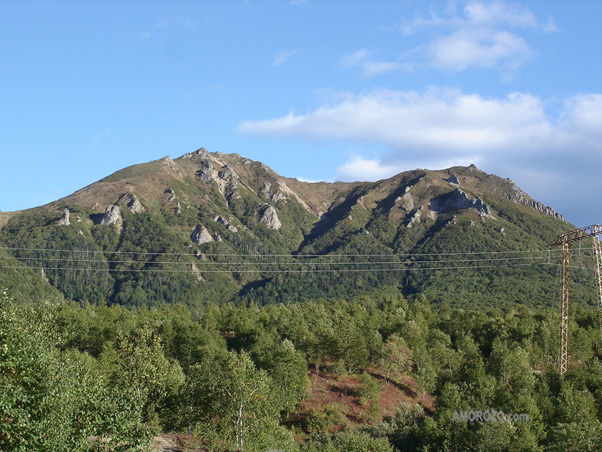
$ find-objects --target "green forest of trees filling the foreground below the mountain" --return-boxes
[0,290,602,452]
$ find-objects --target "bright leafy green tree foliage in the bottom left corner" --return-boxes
[0,293,150,451]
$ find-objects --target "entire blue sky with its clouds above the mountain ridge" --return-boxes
[0,0,602,226]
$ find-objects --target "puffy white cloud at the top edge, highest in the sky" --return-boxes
[400,1,558,72]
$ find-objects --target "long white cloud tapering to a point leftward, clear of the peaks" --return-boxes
[239,88,552,154]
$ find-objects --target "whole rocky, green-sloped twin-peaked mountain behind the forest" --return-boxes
[0,148,594,307]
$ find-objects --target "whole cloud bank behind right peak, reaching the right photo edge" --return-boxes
[238,88,602,223]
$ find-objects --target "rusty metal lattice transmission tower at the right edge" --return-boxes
[550,224,602,375]
